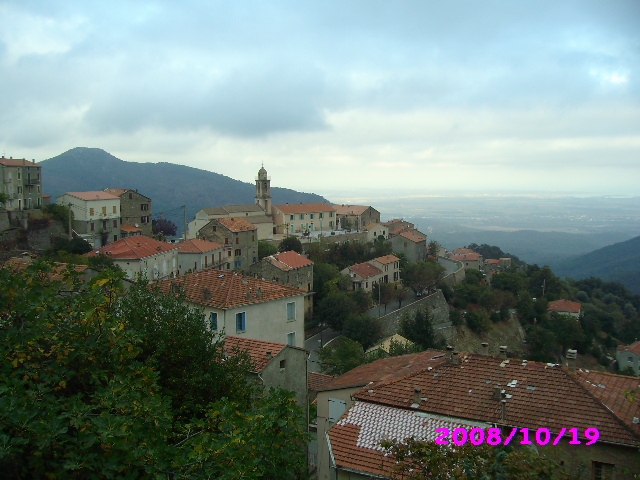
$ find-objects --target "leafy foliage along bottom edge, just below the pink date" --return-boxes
[381,438,571,480]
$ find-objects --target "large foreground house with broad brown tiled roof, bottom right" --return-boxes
[317,347,640,480]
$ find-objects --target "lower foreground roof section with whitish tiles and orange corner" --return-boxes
[328,404,492,478]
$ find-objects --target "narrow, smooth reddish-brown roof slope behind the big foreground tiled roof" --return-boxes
[321,350,448,390]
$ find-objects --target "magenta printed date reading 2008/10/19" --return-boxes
[435,427,600,447]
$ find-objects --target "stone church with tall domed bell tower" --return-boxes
[187,165,275,240]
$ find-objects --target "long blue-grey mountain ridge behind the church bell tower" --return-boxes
[40,147,328,229]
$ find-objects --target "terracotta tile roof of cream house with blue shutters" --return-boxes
[159,269,305,309]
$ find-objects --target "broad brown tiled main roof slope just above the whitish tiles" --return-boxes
[354,354,640,446]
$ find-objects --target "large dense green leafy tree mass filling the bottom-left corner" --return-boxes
[0,262,306,479]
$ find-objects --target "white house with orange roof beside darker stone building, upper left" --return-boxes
[56,190,121,248]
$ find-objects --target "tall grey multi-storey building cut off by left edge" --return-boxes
[0,155,42,211]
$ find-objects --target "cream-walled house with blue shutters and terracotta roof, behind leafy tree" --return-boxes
[155,269,305,347]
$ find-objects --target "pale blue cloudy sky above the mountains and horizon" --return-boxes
[0,0,640,201]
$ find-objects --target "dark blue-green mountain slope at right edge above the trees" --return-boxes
[554,237,640,294]
